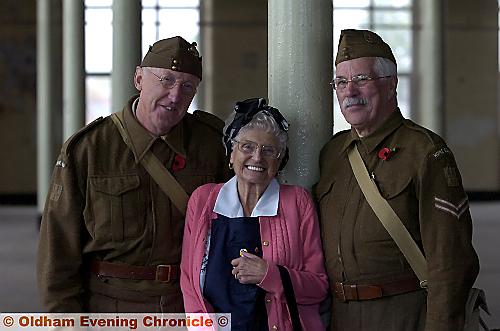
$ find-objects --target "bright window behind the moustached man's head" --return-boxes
[332,0,412,132]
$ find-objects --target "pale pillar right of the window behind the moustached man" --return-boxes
[412,0,444,134]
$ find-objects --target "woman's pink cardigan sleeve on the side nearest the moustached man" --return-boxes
[259,191,328,305]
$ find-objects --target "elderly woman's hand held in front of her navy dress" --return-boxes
[231,252,267,284]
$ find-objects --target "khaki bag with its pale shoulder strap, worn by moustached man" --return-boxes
[348,144,490,331]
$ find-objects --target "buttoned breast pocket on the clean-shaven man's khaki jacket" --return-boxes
[86,175,145,242]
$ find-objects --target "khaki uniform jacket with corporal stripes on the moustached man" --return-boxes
[315,110,479,331]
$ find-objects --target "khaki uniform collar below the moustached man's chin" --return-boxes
[342,108,404,153]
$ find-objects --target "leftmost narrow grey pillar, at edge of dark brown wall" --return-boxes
[36,0,62,213]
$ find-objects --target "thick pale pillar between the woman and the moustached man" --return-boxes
[268,0,333,187]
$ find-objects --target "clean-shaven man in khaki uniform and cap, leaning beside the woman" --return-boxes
[37,37,230,313]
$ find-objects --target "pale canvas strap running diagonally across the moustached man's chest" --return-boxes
[348,144,427,287]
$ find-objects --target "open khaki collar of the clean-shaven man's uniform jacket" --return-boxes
[123,96,189,162]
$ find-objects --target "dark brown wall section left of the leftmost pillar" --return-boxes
[0,0,36,196]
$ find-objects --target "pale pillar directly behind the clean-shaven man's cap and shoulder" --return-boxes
[111,0,142,112]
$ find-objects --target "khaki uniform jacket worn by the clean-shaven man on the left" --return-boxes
[37,97,230,312]
